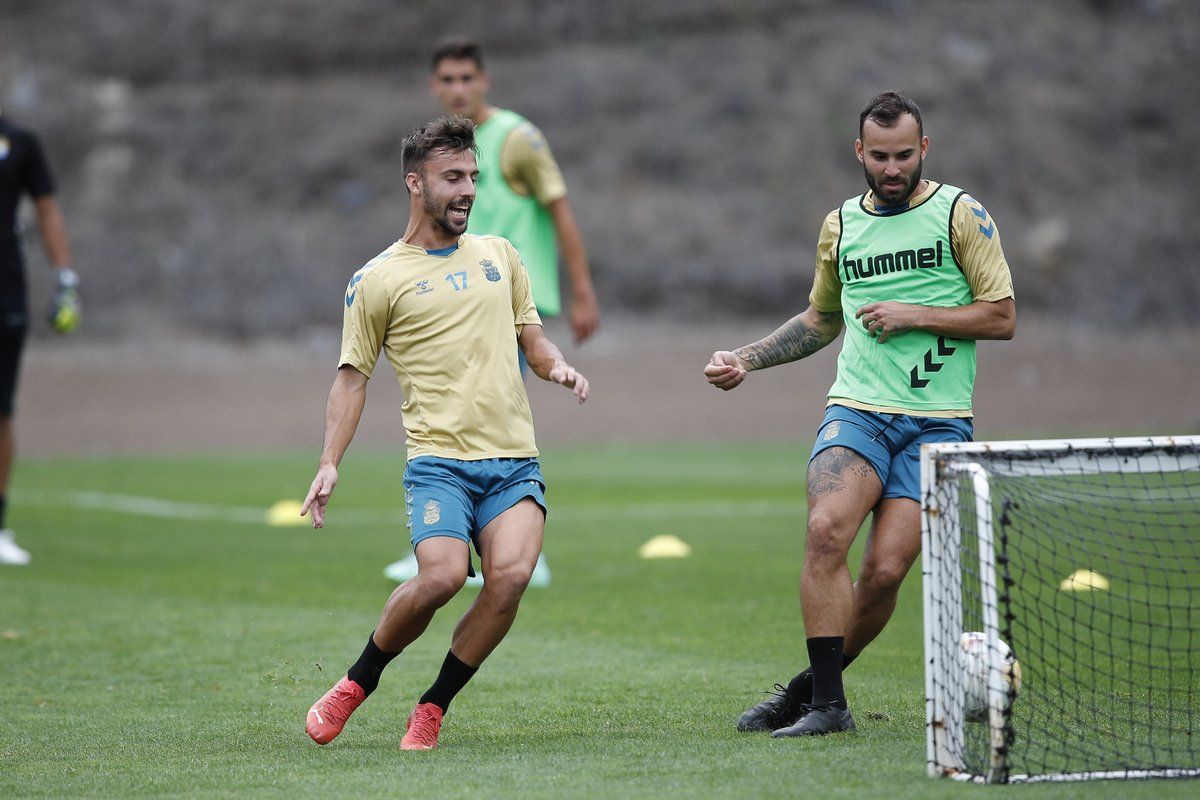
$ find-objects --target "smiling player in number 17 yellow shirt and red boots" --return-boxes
[301,118,589,750]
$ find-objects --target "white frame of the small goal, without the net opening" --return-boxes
[920,437,1200,783]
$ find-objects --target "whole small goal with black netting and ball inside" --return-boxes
[922,437,1200,783]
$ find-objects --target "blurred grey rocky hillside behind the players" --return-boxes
[0,0,1200,338]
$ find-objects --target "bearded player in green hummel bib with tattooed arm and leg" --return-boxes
[704,92,1016,736]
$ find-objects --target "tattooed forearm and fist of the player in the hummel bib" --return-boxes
[704,306,841,391]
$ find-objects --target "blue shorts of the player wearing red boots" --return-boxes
[404,456,546,553]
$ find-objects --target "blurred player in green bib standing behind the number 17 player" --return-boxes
[384,38,600,587]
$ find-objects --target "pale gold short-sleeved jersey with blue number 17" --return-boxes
[338,234,541,461]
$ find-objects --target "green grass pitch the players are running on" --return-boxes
[0,445,1198,800]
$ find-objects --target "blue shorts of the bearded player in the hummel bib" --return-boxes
[809,405,974,503]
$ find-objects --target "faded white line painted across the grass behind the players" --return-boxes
[13,489,806,527]
